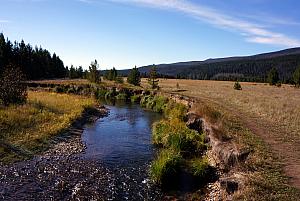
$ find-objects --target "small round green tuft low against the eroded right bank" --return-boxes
[190,157,209,178]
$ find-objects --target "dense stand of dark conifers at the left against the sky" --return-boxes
[0,33,66,80]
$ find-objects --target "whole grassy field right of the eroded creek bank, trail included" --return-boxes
[142,79,300,200]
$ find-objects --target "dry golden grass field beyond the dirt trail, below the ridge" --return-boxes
[143,79,300,141]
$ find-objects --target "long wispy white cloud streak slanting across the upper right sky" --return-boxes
[109,0,300,47]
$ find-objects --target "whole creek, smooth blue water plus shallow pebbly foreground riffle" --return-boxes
[0,104,163,200]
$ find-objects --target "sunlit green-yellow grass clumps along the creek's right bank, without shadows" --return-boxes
[149,95,208,185]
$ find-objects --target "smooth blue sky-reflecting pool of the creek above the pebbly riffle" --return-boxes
[82,100,161,167]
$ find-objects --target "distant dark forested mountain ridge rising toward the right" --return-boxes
[120,48,300,83]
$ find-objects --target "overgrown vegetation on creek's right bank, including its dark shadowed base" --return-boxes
[140,95,217,200]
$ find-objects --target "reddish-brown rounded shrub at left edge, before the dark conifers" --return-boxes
[0,65,27,106]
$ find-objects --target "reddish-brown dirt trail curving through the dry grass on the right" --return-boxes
[189,97,300,189]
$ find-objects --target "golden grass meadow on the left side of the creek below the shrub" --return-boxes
[0,91,94,162]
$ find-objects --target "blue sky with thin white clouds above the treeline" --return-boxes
[0,0,300,69]
